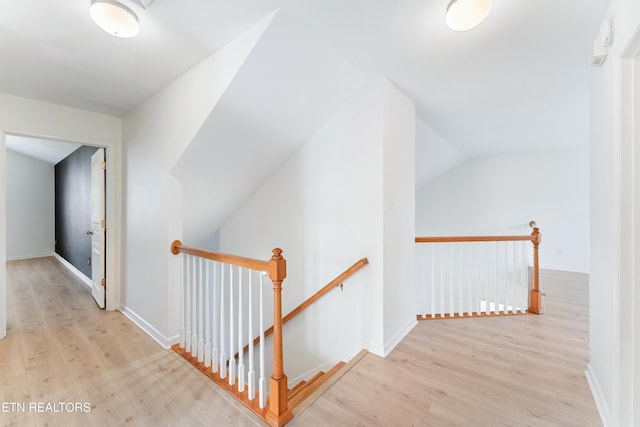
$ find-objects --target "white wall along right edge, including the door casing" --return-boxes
[587,0,640,426]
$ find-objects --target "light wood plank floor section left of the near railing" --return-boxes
[0,258,262,427]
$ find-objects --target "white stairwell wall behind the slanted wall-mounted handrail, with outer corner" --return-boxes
[220,78,415,378]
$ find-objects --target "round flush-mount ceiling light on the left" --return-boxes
[89,0,140,38]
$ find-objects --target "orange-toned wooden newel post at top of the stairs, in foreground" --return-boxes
[266,248,293,426]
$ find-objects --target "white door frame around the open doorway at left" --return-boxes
[0,126,122,339]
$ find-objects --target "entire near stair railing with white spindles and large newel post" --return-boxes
[171,240,292,426]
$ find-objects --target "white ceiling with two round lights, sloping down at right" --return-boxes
[0,0,608,178]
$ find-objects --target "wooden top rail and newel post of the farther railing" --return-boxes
[415,221,542,314]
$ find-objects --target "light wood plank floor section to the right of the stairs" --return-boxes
[290,271,602,427]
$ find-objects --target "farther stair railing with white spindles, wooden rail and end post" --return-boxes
[415,221,542,320]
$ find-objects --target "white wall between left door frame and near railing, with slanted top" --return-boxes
[122,15,268,346]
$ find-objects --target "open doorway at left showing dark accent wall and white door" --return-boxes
[6,140,106,308]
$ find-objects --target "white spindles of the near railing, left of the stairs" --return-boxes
[179,255,268,408]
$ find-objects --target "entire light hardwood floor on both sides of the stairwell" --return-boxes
[0,258,601,426]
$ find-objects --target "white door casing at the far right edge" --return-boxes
[608,10,640,425]
